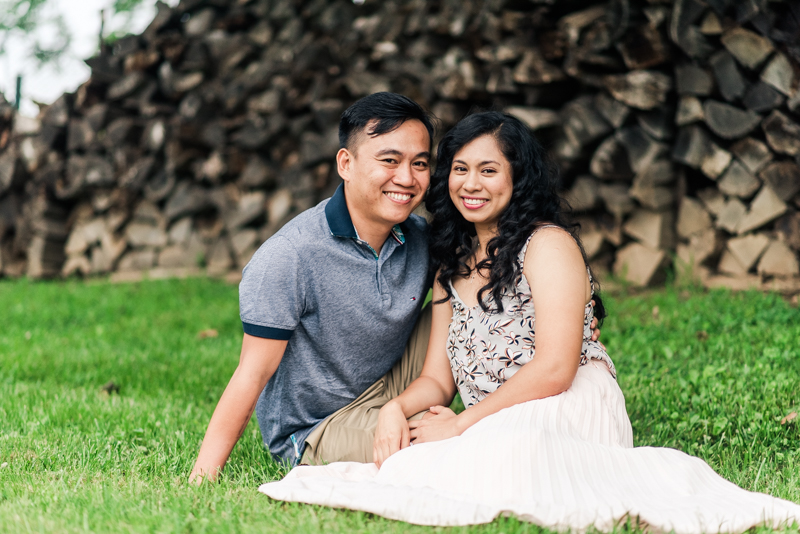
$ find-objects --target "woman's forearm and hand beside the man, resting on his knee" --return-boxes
[373,282,456,467]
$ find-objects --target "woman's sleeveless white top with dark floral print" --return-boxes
[447,225,617,408]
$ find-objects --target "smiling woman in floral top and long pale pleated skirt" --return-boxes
[261,112,800,533]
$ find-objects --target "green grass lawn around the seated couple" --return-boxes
[0,280,800,533]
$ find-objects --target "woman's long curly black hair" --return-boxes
[425,111,606,321]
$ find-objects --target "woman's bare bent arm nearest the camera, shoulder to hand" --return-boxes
[410,228,591,443]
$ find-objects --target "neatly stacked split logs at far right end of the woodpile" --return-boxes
[672,2,800,291]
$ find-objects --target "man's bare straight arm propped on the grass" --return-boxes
[189,334,288,484]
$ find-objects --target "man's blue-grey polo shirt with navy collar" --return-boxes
[239,186,429,462]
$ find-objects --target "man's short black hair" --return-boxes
[339,92,435,152]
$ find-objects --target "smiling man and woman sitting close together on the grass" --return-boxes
[191,93,800,533]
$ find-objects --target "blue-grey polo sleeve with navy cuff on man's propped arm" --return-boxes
[239,236,305,340]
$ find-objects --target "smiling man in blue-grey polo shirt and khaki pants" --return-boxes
[190,93,600,482]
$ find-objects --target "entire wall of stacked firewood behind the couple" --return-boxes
[0,0,800,291]
